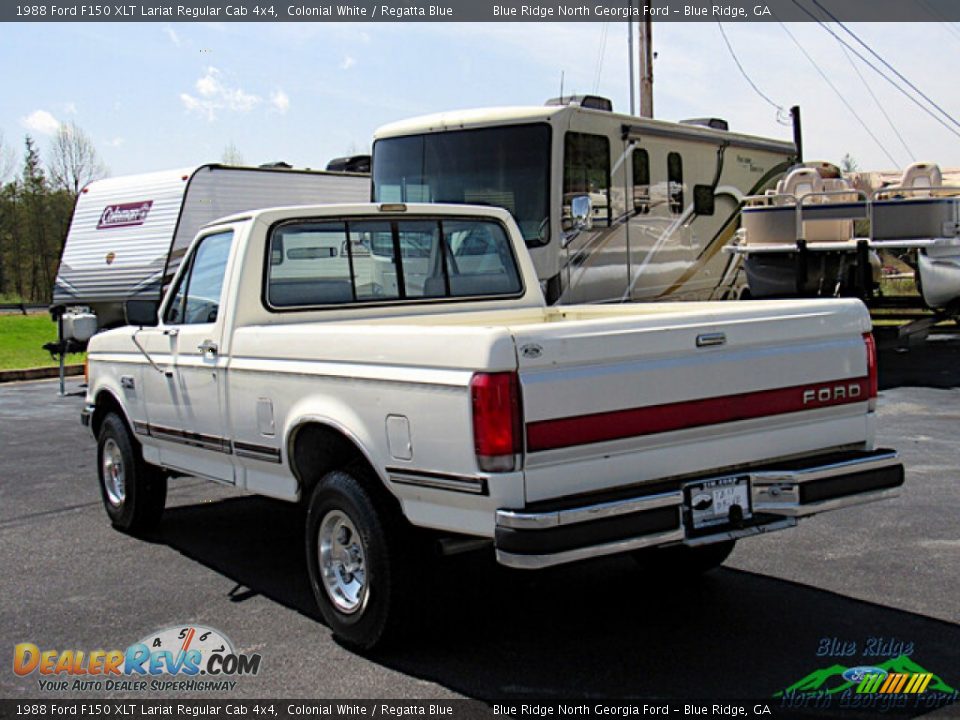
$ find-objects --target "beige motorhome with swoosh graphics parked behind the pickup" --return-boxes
[372,96,798,303]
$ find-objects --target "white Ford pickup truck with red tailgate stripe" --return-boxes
[83,204,903,648]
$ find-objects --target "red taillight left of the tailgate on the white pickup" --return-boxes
[470,372,523,472]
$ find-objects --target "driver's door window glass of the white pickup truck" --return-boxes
[164,231,233,325]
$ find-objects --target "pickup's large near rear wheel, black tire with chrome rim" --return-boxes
[306,467,419,651]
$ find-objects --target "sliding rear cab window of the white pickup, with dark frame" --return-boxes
[263,216,524,311]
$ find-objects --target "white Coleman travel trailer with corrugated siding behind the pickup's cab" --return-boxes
[51,165,370,332]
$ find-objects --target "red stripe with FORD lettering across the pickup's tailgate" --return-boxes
[527,377,870,452]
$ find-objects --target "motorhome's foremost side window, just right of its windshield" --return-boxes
[563,132,610,229]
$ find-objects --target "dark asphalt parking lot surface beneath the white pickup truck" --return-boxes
[0,338,960,717]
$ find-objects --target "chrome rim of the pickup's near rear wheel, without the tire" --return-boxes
[317,510,369,615]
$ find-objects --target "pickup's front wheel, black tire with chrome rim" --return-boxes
[97,412,167,535]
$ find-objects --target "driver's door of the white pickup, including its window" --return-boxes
[145,231,234,483]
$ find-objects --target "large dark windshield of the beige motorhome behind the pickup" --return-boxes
[373,125,550,245]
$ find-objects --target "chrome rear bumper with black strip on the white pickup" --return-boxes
[495,450,903,568]
